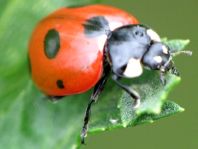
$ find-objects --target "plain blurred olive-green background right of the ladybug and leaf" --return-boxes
[82,0,198,149]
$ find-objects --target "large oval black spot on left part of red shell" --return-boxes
[44,29,60,59]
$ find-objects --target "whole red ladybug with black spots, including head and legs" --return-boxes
[29,5,191,143]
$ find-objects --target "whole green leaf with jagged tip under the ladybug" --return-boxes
[0,0,187,149]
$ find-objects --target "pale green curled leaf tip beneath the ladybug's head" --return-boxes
[120,73,180,126]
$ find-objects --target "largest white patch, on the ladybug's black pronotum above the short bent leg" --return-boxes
[123,58,143,78]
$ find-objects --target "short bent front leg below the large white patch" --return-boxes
[112,74,140,108]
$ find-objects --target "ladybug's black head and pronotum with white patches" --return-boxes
[105,24,190,78]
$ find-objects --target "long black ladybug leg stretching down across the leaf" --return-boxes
[81,63,111,144]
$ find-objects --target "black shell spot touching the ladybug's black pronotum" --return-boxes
[83,16,111,37]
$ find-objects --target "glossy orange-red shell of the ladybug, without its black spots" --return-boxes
[29,5,138,96]
